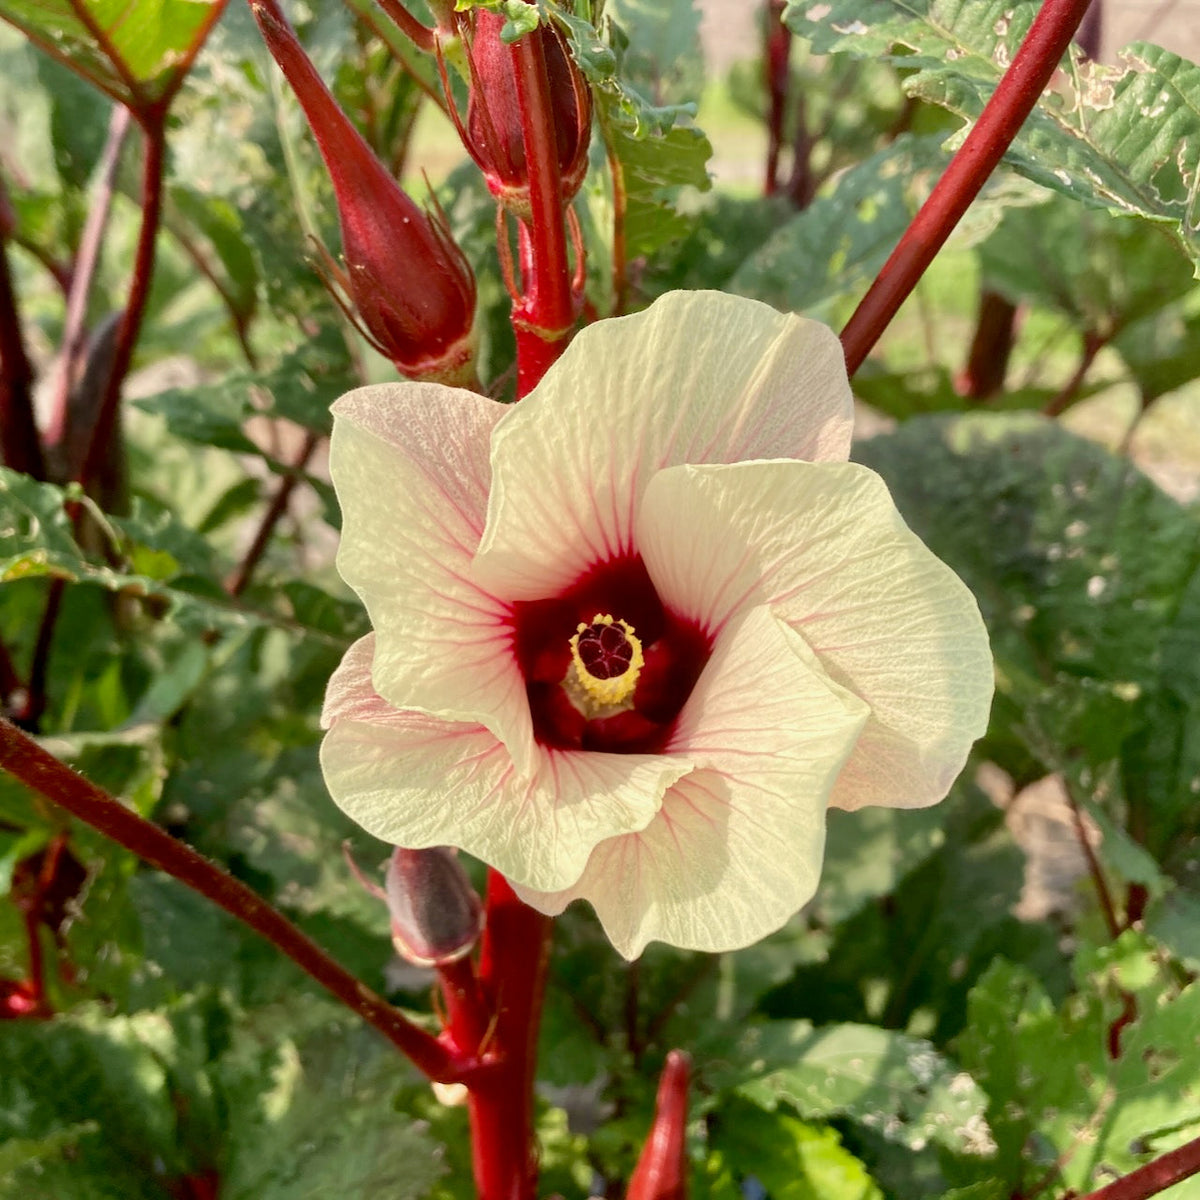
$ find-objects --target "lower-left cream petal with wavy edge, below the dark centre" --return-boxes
[320,635,692,890]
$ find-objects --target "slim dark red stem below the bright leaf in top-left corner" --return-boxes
[78,113,167,487]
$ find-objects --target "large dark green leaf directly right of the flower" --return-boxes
[856,414,1200,809]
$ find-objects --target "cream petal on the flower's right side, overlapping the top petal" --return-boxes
[637,462,992,809]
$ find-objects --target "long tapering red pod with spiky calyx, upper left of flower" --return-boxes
[252,0,475,386]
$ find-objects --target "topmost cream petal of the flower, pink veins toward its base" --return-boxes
[475,292,853,600]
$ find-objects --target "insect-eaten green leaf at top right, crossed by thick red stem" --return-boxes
[785,0,1200,274]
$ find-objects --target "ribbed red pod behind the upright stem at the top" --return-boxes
[458,11,592,220]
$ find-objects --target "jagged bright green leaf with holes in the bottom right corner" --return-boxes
[960,932,1200,1193]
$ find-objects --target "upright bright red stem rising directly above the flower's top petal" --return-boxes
[510,23,575,396]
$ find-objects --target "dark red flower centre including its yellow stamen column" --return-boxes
[512,554,712,754]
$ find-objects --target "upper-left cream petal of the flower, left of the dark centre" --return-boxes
[330,383,533,769]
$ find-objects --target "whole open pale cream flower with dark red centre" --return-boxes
[322,292,992,958]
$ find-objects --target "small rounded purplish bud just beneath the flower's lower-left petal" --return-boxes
[384,846,484,967]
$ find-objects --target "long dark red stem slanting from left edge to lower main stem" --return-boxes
[0,718,492,1082]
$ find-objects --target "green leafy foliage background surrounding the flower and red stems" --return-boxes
[0,0,1200,1200]
